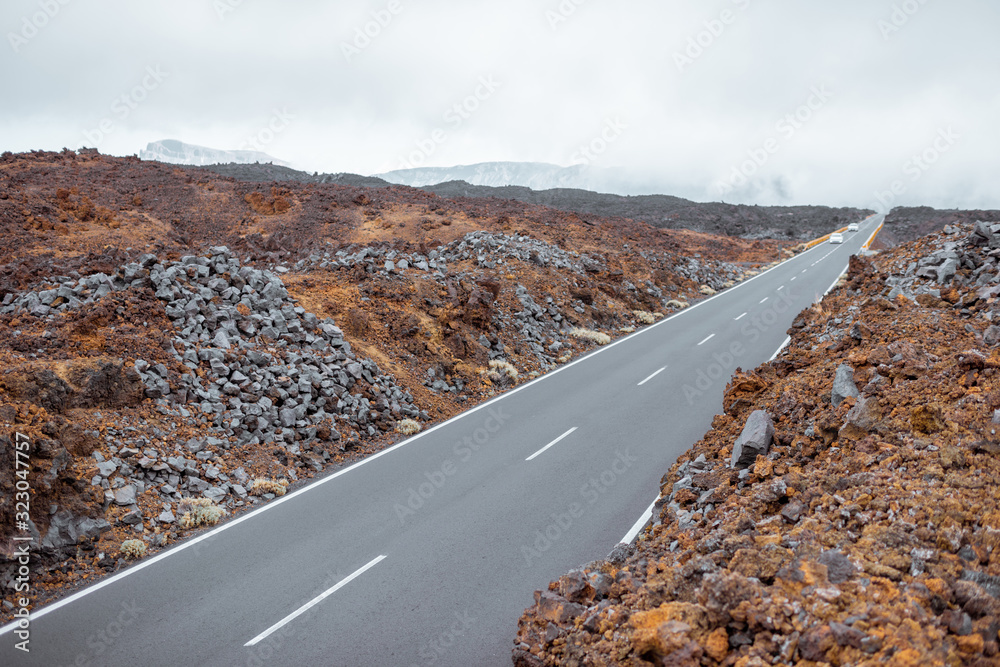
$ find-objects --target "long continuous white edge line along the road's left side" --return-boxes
[0,218,848,637]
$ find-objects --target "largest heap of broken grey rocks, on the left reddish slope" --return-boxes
[2,247,428,516]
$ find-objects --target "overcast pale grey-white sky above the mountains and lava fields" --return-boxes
[0,0,1000,208]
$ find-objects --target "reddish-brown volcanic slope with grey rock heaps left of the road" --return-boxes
[0,151,790,618]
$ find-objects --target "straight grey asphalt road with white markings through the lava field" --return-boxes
[0,216,881,667]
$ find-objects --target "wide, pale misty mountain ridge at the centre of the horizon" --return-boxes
[375,162,663,195]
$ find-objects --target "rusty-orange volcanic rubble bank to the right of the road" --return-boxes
[513,223,1000,667]
